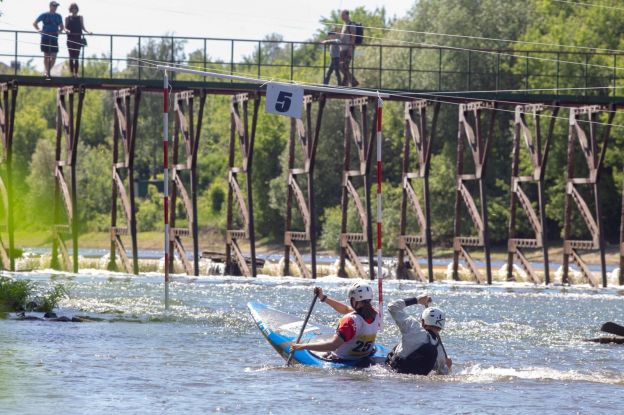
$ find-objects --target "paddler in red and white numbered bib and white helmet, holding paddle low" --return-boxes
[292,282,381,361]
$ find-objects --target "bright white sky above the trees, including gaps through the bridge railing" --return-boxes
[0,0,416,73]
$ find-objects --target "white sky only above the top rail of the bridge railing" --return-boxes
[0,0,415,41]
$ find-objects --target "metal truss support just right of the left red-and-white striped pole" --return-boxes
[169,90,206,275]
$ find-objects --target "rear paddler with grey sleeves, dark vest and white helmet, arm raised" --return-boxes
[386,294,453,375]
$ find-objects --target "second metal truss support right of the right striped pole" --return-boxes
[453,101,496,284]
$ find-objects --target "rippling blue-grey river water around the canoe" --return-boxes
[0,271,624,415]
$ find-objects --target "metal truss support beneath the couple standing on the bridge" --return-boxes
[51,86,85,272]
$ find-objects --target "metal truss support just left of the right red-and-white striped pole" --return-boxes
[338,98,377,279]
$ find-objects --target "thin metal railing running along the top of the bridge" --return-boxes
[0,30,624,95]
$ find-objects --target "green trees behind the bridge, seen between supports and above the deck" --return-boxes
[6,0,624,254]
